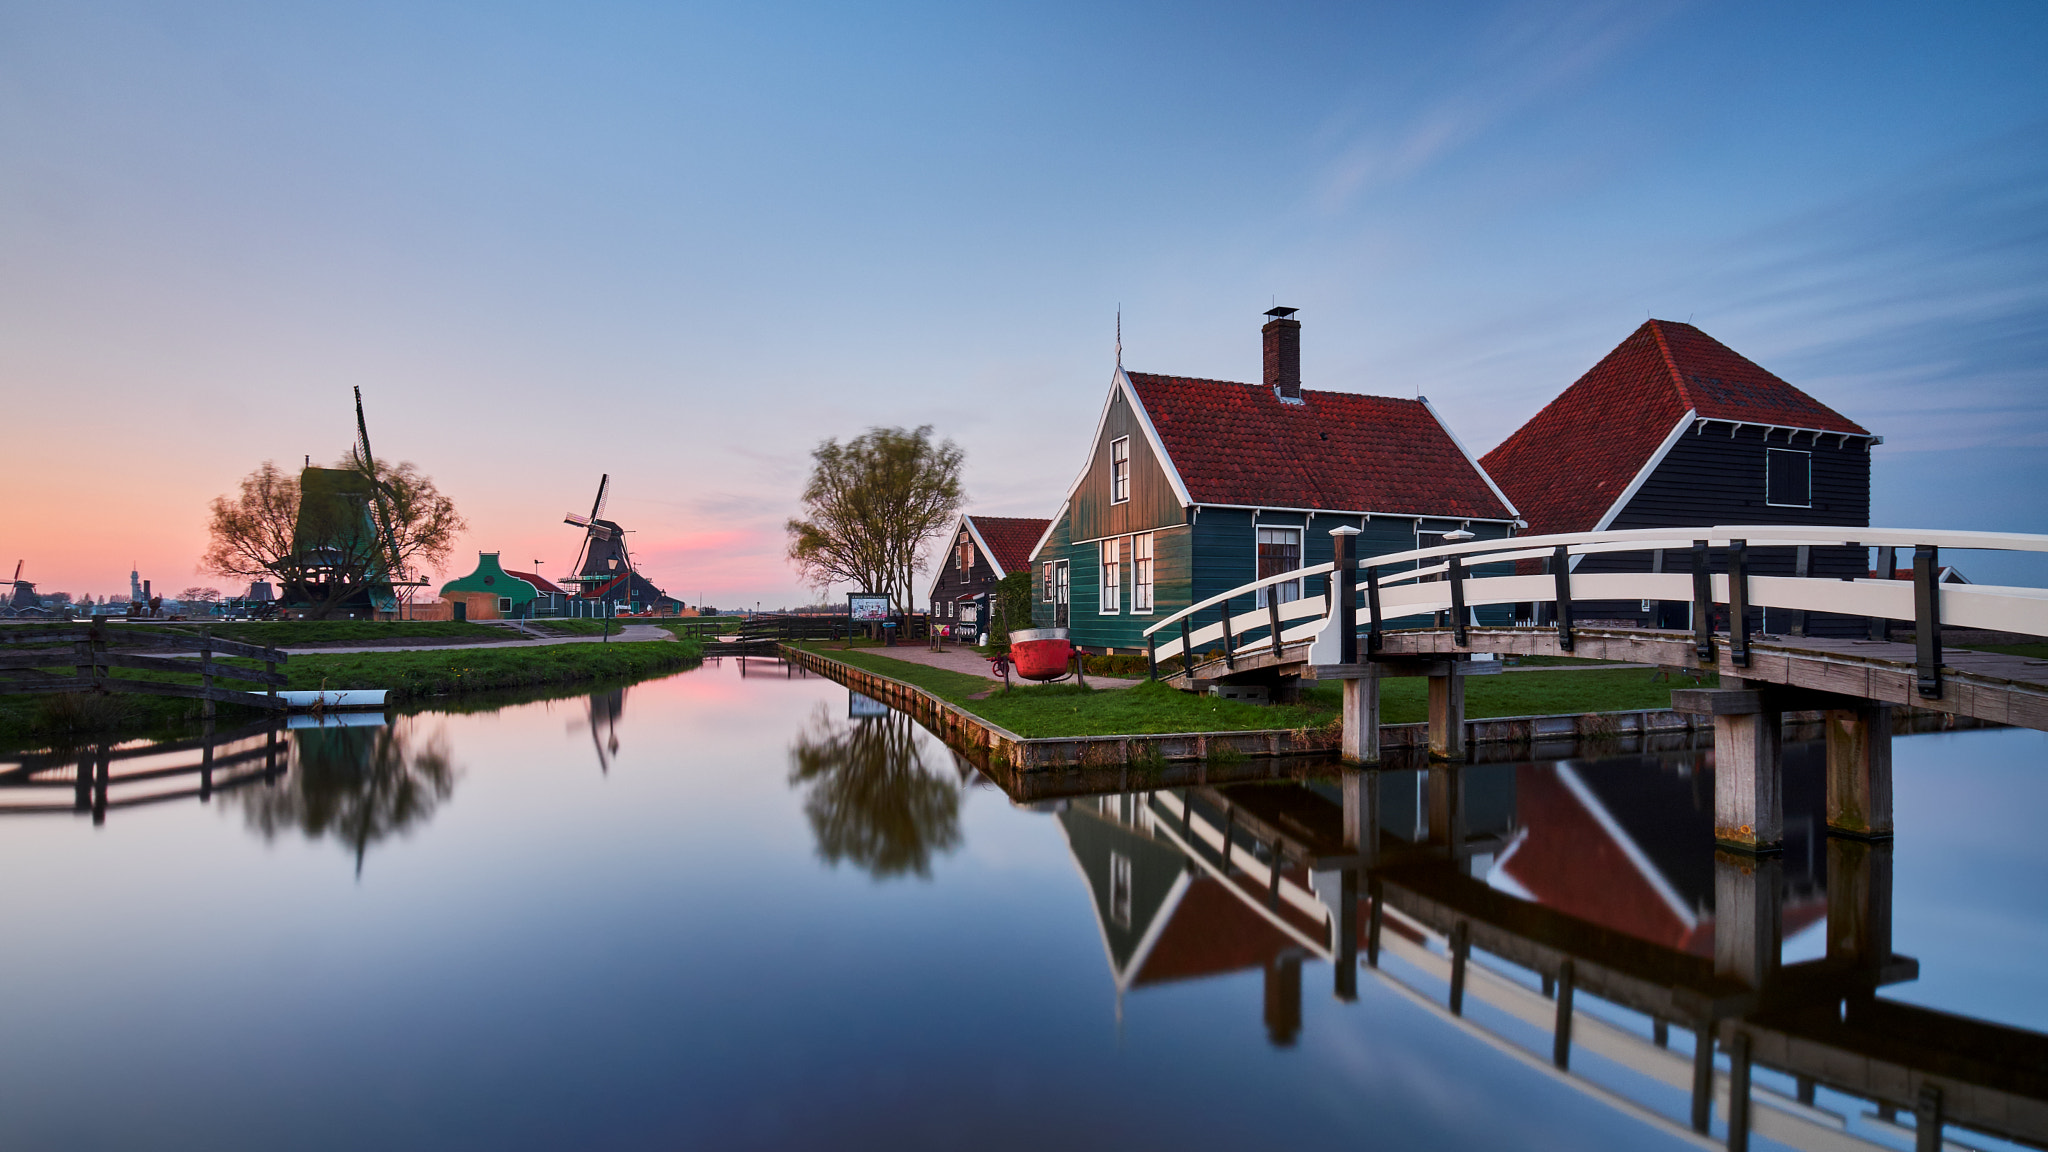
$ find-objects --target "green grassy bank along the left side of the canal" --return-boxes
[0,625,705,746]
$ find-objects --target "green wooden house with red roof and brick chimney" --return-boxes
[1032,307,1516,652]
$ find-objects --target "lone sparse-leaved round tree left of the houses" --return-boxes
[786,424,965,611]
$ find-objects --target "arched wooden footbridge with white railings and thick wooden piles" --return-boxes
[1147,527,2048,851]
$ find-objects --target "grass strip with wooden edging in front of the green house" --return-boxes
[803,644,1716,738]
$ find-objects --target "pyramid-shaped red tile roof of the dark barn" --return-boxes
[1479,320,1870,535]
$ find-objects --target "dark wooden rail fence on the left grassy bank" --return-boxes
[0,619,289,715]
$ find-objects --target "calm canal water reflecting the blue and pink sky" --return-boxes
[0,660,2048,1150]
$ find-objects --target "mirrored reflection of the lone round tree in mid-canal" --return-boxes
[788,705,961,879]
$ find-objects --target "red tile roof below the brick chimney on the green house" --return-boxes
[1128,371,1513,521]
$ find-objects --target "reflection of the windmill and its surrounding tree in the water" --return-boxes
[231,722,457,875]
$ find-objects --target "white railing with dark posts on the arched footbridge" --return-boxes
[1145,525,2048,697]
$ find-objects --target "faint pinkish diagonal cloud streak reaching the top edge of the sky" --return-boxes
[1319,0,1681,209]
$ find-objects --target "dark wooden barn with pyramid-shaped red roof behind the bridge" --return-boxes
[1481,320,1882,635]
